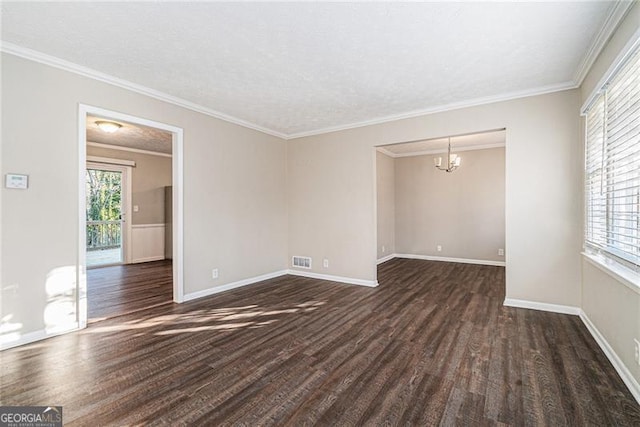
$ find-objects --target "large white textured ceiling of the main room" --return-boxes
[0,1,629,137]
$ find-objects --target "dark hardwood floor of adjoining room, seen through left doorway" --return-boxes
[87,260,173,323]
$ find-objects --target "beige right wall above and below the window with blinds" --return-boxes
[576,3,640,390]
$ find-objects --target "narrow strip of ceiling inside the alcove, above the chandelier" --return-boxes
[381,130,507,157]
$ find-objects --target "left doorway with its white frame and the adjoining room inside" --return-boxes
[77,105,184,327]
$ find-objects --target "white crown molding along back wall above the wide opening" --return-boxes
[286,81,578,139]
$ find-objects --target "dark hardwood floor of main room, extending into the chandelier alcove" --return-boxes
[1,259,640,426]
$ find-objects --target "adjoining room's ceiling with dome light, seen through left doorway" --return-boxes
[87,115,173,154]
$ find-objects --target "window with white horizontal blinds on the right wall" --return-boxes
[585,41,640,272]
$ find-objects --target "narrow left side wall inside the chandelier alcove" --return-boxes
[376,152,396,259]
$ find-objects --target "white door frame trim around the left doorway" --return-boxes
[76,104,184,328]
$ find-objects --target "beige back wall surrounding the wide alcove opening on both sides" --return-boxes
[287,90,582,306]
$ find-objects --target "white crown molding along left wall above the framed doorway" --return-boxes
[0,40,288,139]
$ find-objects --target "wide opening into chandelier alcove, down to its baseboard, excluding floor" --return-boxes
[375,129,507,280]
